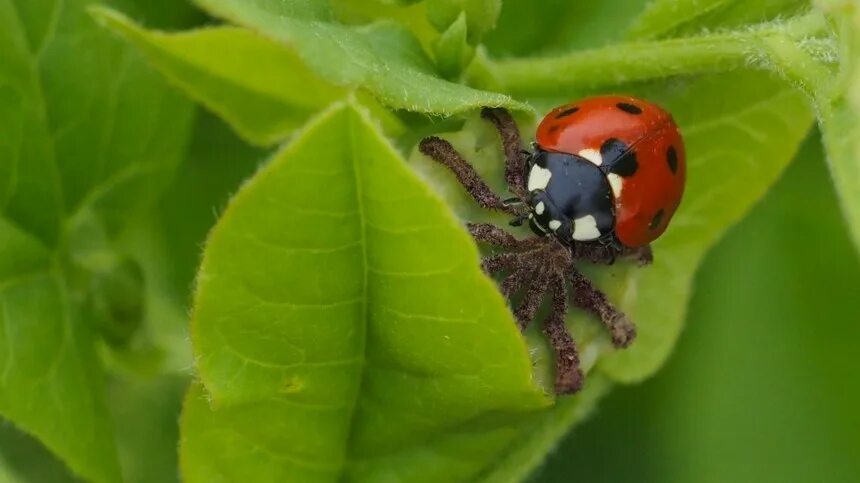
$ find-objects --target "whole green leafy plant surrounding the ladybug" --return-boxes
[0,0,860,482]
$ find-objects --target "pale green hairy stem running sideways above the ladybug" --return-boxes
[470,12,835,96]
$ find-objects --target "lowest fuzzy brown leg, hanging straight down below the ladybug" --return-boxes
[543,273,584,394]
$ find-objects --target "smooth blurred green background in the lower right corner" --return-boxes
[533,132,860,483]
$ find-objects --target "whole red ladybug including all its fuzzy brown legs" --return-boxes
[419,96,686,394]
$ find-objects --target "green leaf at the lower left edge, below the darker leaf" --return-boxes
[0,218,119,482]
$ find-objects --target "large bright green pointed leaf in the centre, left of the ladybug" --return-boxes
[181,106,548,482]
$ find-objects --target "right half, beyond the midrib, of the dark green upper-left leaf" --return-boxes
[38,0,192,236]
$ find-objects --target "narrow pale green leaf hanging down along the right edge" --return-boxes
[819,1,860,250]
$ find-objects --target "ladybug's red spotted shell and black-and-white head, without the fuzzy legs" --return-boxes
[526,96,686,251]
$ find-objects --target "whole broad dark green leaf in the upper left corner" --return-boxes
[0,0,191,244]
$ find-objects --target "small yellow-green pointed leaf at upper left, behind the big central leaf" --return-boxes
[92,8,345,144]
